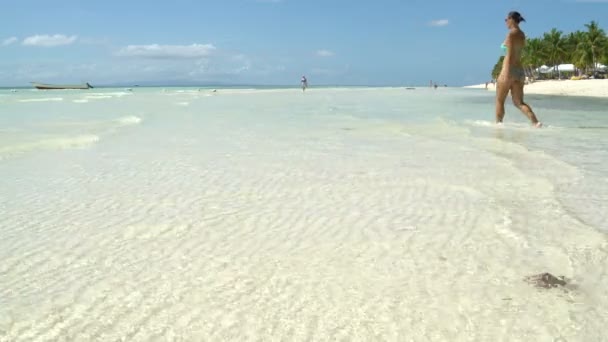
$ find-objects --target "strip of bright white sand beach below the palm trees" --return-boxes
[464,79,608,97]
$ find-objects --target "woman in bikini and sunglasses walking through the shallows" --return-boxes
[496,11,542,127]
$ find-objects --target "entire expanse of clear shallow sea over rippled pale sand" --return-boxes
[0,88,608,341]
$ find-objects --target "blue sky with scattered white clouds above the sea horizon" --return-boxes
[0,0,608,86]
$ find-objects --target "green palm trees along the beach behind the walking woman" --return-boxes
[492,21,608,79]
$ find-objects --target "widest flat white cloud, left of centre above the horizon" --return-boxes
[117,44,215,59]
